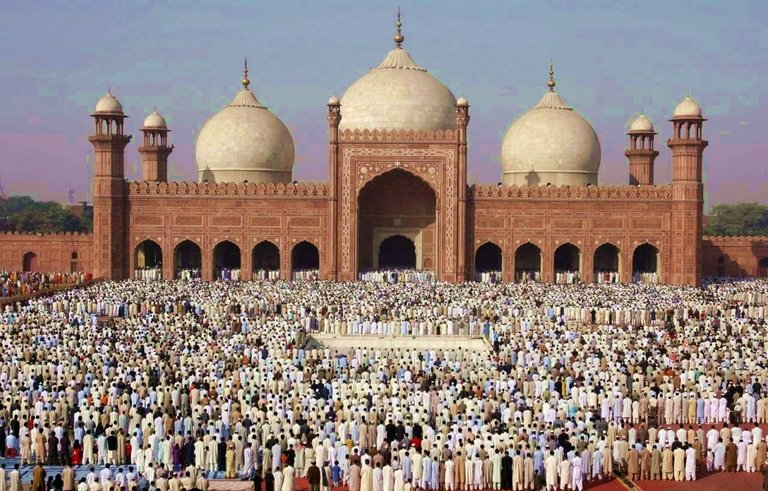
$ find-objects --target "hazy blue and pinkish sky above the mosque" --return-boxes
[0,0,768,207]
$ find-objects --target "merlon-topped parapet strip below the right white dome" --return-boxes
[469,184,672,200]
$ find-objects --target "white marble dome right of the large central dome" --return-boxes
[501,87,600,186]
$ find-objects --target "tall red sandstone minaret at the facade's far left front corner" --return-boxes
[88,90,131,280]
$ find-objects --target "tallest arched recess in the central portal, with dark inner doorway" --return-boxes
[357,169,437,271]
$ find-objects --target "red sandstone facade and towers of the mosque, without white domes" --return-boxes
[0,103,768,285]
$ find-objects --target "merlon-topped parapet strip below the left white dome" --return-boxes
[128,181,328,199]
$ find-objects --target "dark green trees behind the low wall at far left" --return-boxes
[0,196,91,233]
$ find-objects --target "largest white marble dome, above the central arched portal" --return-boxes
[339,20,456,130]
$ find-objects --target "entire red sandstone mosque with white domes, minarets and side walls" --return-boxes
[0,17,768,285]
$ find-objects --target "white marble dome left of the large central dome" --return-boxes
[195,83,295,183]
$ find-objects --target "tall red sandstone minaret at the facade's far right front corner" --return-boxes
[667,96,707,285]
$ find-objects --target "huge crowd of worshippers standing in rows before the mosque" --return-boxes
[0,279,768,491]
